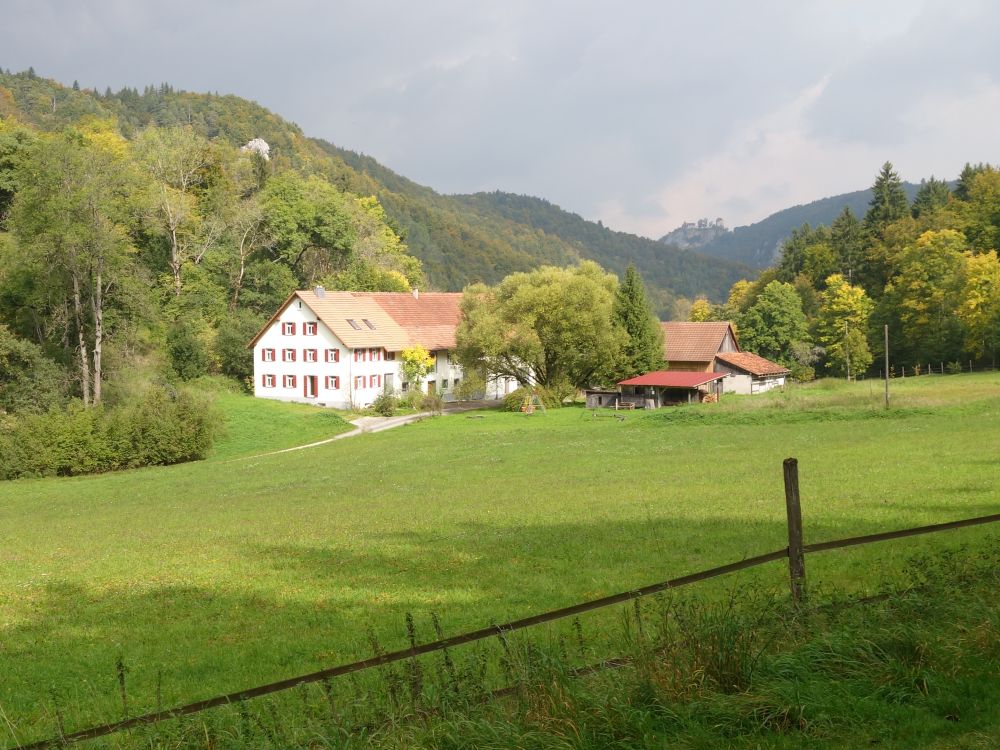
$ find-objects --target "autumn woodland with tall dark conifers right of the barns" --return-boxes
[689,162,1000,379]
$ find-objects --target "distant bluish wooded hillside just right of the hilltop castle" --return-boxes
[680,182,920,268]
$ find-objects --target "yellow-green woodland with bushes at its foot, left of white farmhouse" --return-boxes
[0,71,426,477]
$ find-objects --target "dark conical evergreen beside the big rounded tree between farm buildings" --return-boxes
[611,263,663,380]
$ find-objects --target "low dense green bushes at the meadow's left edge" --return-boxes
[0,386,218,479]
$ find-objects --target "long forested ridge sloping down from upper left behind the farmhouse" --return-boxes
[0,72,747,317]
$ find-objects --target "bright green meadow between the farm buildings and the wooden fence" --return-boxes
[0,374,1000,745]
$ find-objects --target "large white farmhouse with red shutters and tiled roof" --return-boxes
[249,287,517,409]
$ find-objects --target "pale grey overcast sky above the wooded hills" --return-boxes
[0,0,1000,237]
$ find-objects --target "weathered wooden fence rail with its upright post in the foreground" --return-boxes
[10,458,1000,750]
